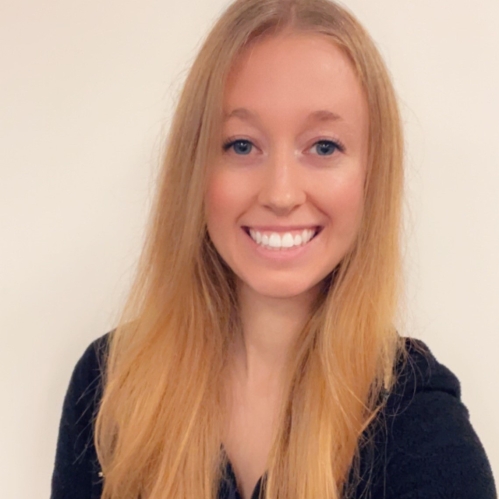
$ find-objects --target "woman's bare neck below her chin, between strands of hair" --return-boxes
[234,284,316,384]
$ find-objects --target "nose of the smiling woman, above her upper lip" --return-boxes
[258,151,306,215]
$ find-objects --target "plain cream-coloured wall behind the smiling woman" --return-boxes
[0,0,499,499]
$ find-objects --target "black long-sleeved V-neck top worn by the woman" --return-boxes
[51,335,497,499]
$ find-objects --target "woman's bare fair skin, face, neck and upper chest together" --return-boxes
[205,34,369,499]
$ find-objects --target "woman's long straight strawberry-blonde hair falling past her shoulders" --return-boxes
[95,0,403,499]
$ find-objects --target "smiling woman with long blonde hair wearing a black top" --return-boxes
[52,0,496,499]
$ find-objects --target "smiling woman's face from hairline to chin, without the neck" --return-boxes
[205,34,369,298]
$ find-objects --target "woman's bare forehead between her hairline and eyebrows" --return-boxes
[224,34,366,129]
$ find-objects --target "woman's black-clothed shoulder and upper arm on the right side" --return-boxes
[374,338,497,499]
